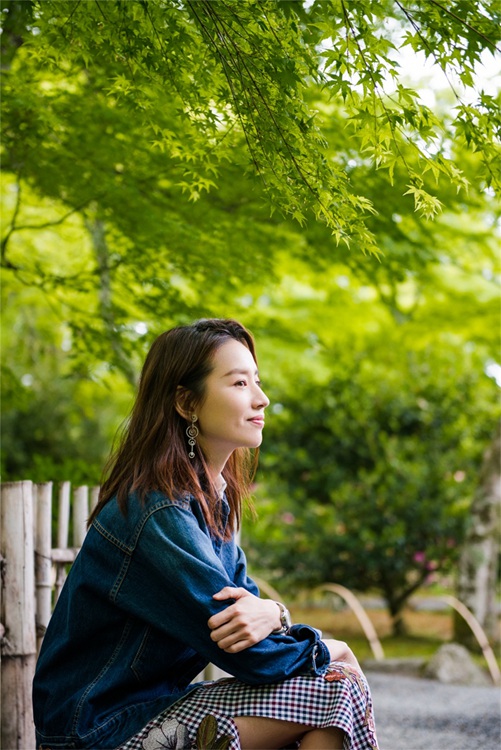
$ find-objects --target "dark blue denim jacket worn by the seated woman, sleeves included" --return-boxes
[33,493,329,750]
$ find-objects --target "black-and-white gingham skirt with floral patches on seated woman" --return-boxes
[117,662,378,750]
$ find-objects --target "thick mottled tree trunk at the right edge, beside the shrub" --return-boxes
[454,426,501,648]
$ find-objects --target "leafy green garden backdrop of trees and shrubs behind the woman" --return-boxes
[1,0,501,660]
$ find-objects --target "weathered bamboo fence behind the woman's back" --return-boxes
[0,481,99,750]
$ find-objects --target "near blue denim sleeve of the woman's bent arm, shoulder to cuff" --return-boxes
[114,506,330,684]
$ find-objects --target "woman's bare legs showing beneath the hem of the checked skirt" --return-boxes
[234,716,344,750]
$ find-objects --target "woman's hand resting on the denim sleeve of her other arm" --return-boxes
[208,586,281,654]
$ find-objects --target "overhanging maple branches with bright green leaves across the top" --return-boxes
[3,0,501,251]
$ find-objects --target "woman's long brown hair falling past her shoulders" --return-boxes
[89,318,259,537]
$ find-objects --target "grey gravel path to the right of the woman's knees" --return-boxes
[366,671,501,750]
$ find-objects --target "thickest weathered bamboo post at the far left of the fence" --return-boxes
[0,482,36,750]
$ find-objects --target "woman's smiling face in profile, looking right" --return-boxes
[196,339,270,471]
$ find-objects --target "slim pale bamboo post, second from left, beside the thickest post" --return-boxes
[34,482,52,651]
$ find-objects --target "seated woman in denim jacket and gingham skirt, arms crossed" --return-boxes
[34,320,377,750]
